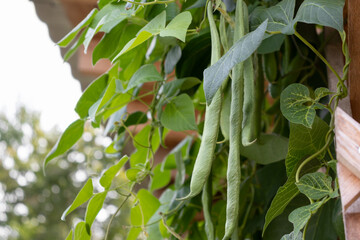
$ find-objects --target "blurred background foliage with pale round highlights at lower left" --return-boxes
[0,107,131,240]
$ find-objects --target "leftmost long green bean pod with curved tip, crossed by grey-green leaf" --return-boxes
[179,1,222,200]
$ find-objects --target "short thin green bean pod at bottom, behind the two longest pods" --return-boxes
[201,172,215,240]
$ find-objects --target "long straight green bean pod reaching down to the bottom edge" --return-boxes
[223,0,245,240]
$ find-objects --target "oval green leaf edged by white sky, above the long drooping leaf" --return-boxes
[75,74,109,118]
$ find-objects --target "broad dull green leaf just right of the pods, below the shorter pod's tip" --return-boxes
[240,134,289,165]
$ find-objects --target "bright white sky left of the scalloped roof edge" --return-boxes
[0,0,81,130]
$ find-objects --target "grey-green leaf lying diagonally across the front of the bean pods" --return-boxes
[204,20,267,105]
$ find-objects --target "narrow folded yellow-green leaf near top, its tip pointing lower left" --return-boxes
[113,11,166,59]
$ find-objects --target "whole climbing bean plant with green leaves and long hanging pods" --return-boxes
[44,0,350,240]
